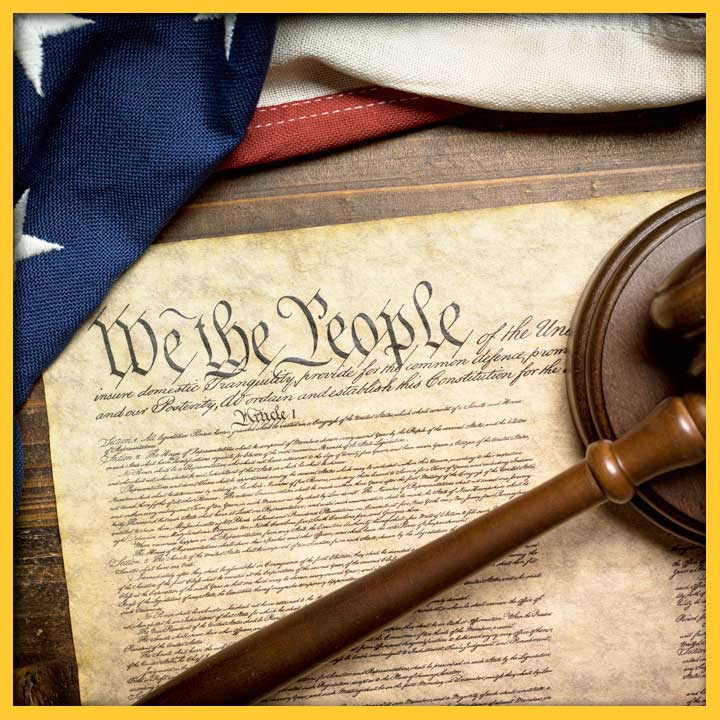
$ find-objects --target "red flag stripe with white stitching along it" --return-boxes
[219,87,470,170]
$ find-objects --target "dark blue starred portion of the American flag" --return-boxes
[14,14,275,509]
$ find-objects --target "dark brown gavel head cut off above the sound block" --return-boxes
[650,246,706,384]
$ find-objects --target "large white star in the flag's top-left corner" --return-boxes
[13,13,93,97]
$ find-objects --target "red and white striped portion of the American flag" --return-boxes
[224,13,705,168]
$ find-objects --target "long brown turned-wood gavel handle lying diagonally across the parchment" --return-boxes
[136,394,705,705]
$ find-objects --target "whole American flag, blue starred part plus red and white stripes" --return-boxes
[14,14,705,508]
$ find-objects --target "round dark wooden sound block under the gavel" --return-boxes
[567,192,705,544]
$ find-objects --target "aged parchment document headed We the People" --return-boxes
[45,192,705,705]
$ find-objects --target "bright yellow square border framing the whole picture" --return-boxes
[0,0,720,720]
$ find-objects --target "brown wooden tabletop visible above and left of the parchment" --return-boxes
[14,103,705,705]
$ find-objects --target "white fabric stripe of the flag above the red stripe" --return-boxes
[260,14,705,113]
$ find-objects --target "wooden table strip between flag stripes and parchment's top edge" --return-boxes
[158,103,705,242]
